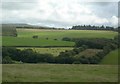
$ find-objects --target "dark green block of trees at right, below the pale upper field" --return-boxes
[73,38,115,49]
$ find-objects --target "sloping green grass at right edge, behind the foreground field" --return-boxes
[101,49,120,65]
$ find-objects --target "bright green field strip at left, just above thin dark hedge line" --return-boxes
[2,37,75,47]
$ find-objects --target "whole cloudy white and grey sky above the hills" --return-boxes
[0,0,118,28]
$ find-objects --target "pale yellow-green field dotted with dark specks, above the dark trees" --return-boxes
[18,47,73,56]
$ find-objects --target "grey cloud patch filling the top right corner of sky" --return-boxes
[89,2,118,18]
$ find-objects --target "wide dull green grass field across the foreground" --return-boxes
[2,64,118,82]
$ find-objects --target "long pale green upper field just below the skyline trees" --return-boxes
[17,29,117,39]
